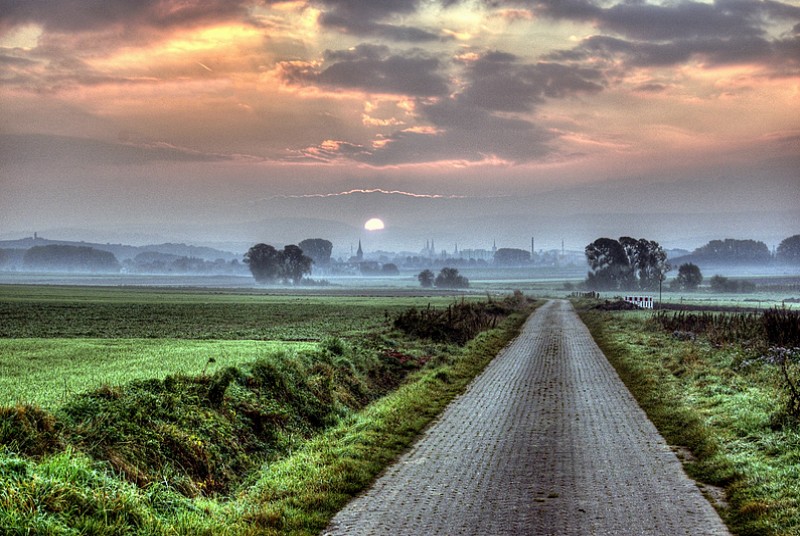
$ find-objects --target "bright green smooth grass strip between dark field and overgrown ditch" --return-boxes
[0,338,316,408]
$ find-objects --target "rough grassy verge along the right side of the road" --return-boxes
[582,306,800,536]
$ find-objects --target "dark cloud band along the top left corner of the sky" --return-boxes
[0,0,253,33]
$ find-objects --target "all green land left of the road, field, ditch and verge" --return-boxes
[0,286,530,536]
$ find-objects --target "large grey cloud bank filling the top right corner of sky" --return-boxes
[536,0,800,76]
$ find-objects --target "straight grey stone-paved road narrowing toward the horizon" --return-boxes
[323,301,729,536]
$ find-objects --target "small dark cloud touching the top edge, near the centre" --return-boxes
[316,0,441,43]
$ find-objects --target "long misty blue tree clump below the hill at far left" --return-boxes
[22,244,120,273]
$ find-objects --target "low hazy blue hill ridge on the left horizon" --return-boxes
[0,237,241,262]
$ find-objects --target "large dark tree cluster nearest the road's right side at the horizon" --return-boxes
[585,236,670,290]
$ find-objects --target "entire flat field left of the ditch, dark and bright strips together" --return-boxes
[0,285,478,407]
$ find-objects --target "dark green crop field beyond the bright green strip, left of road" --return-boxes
[0,285,481,341]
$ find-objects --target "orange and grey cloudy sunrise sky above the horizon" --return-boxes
[0,0,800,255]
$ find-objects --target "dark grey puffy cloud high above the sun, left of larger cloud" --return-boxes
[283,45,448,97]
